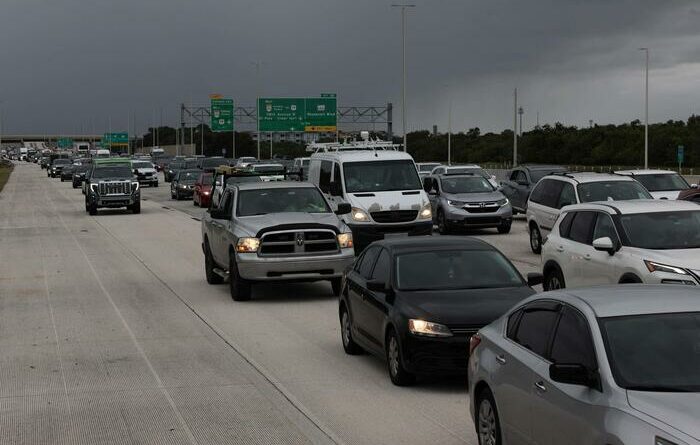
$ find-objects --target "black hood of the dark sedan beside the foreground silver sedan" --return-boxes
[400,286,535,327]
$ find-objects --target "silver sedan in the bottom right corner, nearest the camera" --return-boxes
[469,285,700,445]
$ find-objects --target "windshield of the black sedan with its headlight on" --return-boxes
[396,250,523,290]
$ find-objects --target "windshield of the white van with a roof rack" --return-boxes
[343,159,421,193]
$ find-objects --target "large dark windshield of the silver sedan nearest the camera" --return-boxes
[600,312,700,392]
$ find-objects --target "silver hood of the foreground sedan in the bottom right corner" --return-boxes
[627,391,700,440]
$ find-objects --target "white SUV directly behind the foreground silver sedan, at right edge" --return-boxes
[542,200,700,290]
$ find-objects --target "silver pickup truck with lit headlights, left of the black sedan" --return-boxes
[202,181,354,301]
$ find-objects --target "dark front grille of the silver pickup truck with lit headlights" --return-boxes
[260,230,340,256]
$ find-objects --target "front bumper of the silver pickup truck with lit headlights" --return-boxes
[236,249,355,281]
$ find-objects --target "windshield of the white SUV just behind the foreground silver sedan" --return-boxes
[620,210,700,249]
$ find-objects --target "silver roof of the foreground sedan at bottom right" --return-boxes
[537,284,700,318]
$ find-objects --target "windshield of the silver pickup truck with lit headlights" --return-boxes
[238,187,331,216]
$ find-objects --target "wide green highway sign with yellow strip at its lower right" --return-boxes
[258,94,338,132]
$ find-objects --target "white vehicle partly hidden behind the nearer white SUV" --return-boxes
[526,173,652,253]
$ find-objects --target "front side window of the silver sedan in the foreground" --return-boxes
[550,307,598,369]
